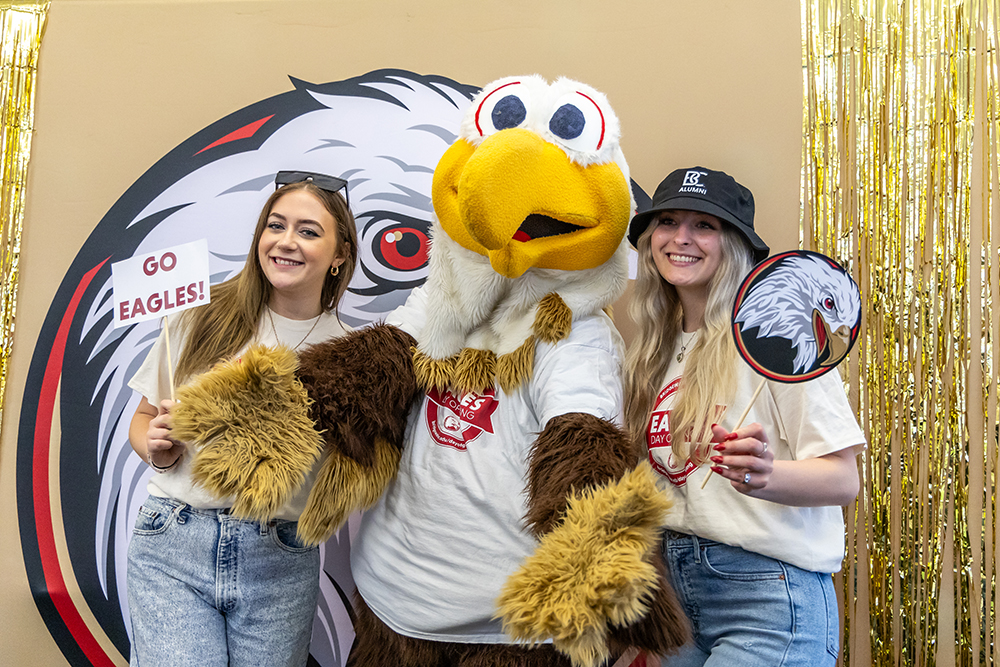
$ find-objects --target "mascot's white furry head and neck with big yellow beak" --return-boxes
[417,75,634,390]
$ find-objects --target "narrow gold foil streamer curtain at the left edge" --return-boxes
[0,2,49,434]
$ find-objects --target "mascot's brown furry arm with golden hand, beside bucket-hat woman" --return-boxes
[499,414,690,664]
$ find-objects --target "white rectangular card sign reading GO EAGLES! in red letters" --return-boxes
[111,239,210,327]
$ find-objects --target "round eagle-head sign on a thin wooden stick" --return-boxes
[702,250,861,487]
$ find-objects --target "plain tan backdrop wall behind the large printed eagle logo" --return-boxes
[0,0,802,665]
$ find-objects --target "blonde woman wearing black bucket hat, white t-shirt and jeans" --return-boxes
[625,167,864,667]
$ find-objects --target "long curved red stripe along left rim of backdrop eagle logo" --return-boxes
[31,257,114,667]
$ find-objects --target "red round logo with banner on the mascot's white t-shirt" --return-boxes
[427,387,497,452]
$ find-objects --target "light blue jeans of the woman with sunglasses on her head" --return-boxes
[127,496,320,667]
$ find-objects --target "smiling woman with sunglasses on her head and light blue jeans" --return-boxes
[127,172,358,667]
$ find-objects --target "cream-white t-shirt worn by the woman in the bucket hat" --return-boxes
[646,334,865,572]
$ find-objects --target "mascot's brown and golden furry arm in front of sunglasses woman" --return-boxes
[174,325,418,544]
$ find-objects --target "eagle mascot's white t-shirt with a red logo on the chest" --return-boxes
[351,290,622,643]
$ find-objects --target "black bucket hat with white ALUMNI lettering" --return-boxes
[628,167,770,262]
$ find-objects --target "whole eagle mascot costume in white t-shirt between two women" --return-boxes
[174,76,689,667]
